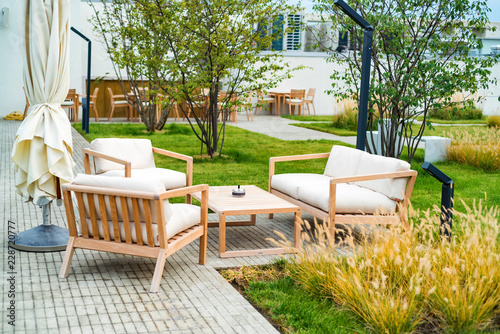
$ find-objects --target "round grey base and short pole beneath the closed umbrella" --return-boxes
[9,202,69,252]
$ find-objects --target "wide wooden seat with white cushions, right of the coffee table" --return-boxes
[269,145,417,236]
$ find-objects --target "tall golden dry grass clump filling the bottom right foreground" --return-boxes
[272,204,500,333]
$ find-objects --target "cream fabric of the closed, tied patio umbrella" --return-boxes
[11,0,75,203]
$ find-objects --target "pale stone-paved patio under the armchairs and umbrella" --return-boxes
[0,118,328,334]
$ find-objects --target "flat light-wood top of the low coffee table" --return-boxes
[193,185,300,215]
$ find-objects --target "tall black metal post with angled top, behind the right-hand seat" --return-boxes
[334,0,373,151]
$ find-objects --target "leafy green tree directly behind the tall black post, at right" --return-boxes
[315,0,498,161]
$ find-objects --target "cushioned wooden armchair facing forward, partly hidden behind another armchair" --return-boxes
[83,138,193,203]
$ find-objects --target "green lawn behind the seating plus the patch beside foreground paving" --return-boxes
[74,124,500,333]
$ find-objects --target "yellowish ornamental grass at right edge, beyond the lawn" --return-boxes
[447,128,500,171]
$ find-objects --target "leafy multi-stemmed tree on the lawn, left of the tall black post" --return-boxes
[94,0,298,157]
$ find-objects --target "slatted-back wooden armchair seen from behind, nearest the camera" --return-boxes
[59,174,208,292]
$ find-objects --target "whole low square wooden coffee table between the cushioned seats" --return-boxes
[193,186,300,258]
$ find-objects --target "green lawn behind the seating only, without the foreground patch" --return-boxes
[75,124,500,214]
